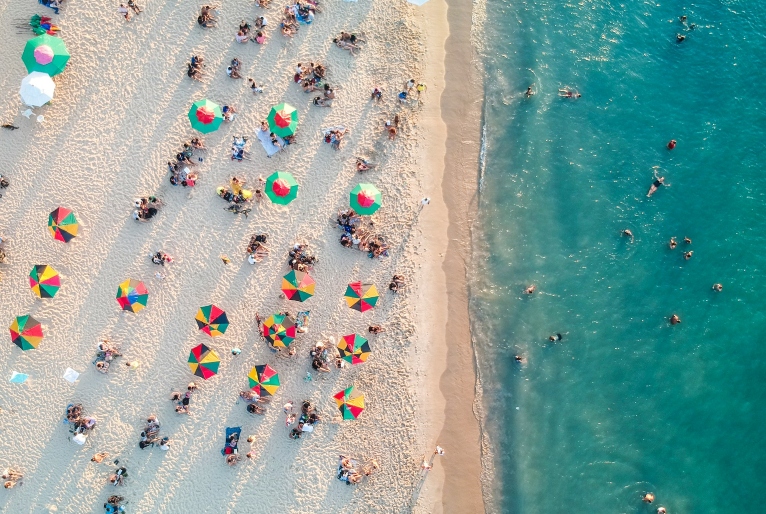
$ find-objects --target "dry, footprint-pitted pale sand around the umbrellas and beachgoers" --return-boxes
[0,0,472,513]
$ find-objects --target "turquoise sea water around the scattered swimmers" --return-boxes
[471,0,766,514]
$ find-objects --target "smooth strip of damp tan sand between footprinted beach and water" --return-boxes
[415,0,485,512]
